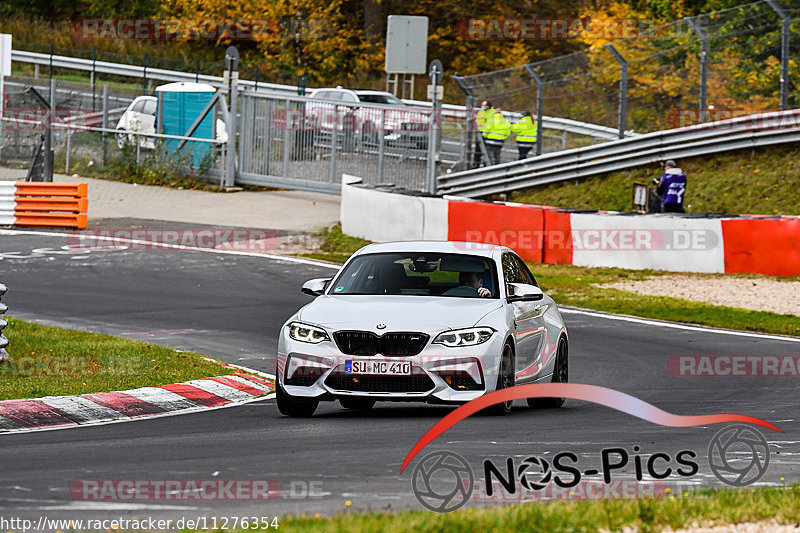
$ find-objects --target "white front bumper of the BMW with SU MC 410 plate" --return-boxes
[275,328,502,403]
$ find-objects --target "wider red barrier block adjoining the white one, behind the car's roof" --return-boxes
[447,201,544,263]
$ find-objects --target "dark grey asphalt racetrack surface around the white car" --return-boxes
[0,227,800,518]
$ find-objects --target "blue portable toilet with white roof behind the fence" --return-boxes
[156,82,216,166]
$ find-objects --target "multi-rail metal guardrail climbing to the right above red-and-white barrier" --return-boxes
[437,109,800,198]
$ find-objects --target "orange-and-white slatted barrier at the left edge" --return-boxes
[0,181,89,229]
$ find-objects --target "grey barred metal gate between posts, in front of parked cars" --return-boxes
[238,93,433,192]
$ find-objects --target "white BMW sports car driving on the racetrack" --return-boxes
[275,241,569,416]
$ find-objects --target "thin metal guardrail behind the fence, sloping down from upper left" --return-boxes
[11,50,633,140]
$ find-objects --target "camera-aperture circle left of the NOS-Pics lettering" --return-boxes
[411,451,475,513]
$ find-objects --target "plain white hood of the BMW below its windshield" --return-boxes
[298,295,501,332]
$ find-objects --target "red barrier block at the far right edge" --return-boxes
[722,219,800,276]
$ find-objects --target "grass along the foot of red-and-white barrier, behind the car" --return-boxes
[303,225,800,336]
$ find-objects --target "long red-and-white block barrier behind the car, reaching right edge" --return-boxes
[341,183,800,276]
